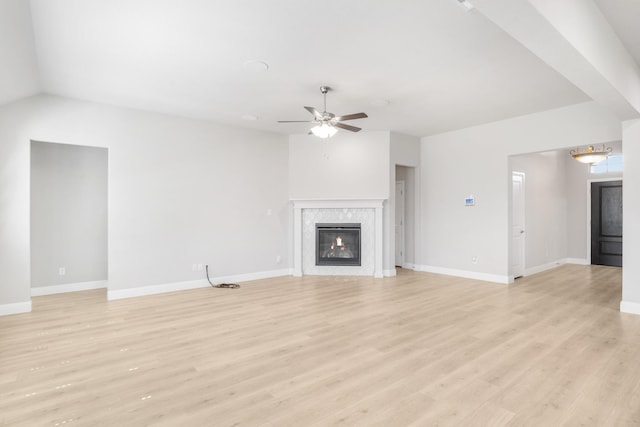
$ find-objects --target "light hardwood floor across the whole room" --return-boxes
[0,265,640,426]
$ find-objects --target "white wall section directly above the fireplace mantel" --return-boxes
[289,131,389,200]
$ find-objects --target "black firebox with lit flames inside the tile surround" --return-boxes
[316,223,361,266]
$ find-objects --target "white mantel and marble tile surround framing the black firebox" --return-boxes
[291,199,384,278]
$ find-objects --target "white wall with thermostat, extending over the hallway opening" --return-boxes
[420,102,626,282]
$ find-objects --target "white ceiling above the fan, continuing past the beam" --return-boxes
[8,0,640,136]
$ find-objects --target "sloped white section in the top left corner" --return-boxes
[0,0,40,105]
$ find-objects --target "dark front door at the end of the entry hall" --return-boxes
[591,181,622,267]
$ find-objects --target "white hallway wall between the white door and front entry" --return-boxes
[511,150,568,274]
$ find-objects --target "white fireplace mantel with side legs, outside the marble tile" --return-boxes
[291,199,384,278]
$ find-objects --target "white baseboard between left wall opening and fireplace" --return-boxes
[107,269,291,301]
